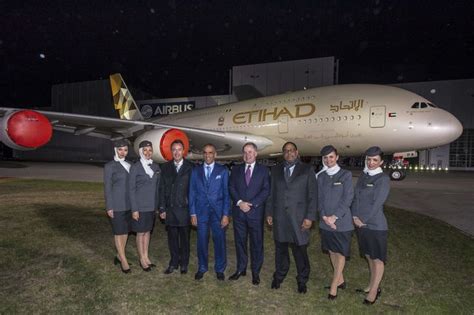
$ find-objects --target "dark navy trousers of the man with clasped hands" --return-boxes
[233,214,263,274]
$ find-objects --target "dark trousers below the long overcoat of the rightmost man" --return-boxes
[273,241,310,284]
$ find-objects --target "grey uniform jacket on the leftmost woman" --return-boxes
[104,161,130,211]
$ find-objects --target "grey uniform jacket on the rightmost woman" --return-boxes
[351,173,390,231]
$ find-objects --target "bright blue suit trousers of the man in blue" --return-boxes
[197,211,227,272]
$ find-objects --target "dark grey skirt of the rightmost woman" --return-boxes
[356,228,388,263]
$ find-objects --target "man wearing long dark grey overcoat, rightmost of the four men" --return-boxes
[265,142,317,293]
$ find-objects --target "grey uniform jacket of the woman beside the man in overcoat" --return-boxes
[318,169,354,232]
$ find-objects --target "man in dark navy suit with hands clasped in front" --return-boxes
[229,142,270,285]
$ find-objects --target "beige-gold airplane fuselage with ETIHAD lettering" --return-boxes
[156,84,462,158]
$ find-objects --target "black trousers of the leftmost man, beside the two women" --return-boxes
[166,225,191,268]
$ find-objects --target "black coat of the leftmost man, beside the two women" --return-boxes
[160,160,194,226]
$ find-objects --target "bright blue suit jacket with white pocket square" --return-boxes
[189,163,230,222]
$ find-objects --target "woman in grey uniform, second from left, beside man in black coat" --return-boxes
[130,140,160,271]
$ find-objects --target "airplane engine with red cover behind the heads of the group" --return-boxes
[134,128,189,162]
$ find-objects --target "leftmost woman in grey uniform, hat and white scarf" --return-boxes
[104,140,131,273]
